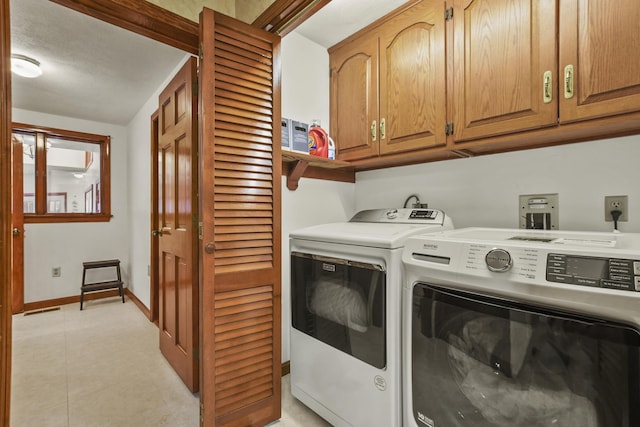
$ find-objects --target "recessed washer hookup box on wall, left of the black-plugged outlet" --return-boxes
[519,193,559,230]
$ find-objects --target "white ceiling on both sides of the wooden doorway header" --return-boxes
[10,0,406,126]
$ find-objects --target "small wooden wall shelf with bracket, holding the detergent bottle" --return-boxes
[282,150,356,191]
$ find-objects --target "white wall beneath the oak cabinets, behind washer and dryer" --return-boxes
[356,136,640,232]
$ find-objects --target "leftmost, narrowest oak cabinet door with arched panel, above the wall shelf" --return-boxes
[329,38,379,160]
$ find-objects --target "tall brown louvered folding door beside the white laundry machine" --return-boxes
[199,9,281,426]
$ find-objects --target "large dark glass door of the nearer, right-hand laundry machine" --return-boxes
[408,284,640,427]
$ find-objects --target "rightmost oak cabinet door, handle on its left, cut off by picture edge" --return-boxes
[560,0,640,122]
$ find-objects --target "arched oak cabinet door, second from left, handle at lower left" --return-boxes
[379,1,446,154]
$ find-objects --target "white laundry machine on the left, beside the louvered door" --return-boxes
[290,209,453,427]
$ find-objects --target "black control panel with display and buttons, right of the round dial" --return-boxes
[546,253,640,291]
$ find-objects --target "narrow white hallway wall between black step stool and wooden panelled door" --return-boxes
[127,55,189,308]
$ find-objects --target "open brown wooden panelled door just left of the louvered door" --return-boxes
[158,58,198,392]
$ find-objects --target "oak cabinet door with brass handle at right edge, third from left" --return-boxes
[453,0,558,142]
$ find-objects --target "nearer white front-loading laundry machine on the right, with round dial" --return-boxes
[403,228,640,427]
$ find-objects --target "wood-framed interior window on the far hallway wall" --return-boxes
[13,123,111,223]
